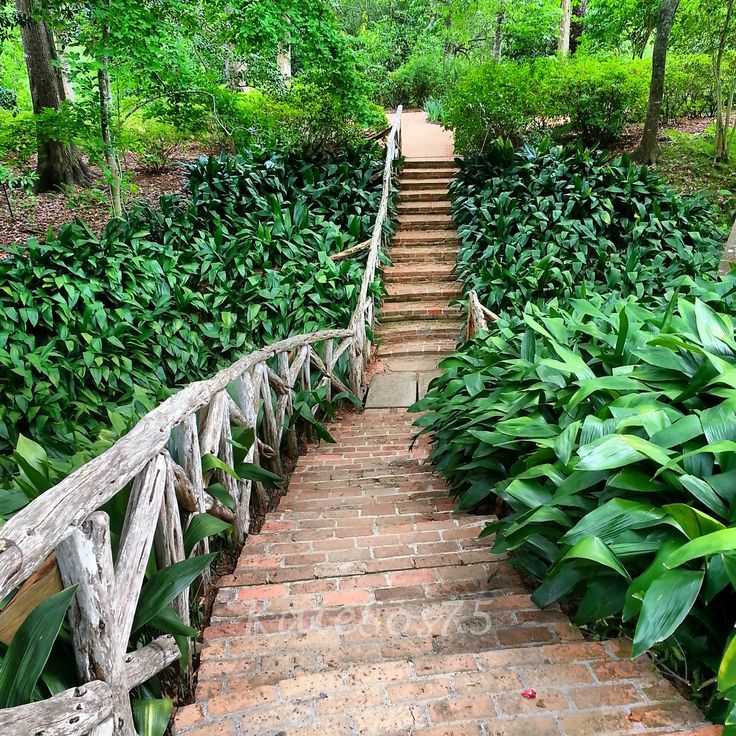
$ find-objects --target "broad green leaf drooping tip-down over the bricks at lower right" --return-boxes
[631,570,705,657]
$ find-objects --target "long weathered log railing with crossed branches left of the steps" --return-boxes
[0,108,401,736]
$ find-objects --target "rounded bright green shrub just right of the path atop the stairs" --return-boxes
[447,62,535,154]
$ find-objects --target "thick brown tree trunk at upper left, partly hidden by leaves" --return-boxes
[15,0,88,192]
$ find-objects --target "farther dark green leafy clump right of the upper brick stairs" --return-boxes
[452,141,723,311]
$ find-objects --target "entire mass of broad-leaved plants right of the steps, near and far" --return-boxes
[414,143,736,722]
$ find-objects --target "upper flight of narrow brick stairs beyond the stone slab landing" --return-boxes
[376,159,462,374]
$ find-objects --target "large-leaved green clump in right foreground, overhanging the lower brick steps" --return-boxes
[414,284,736,719]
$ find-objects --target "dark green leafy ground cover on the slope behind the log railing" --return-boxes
[0,147,382,474]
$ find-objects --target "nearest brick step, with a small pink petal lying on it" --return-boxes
[181,637,706,736]
